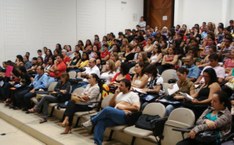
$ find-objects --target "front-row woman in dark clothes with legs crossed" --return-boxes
[28,73,70,123]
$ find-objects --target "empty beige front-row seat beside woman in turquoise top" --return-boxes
[162,108,195,145]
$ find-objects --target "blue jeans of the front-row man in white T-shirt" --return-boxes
[91,107,126,145]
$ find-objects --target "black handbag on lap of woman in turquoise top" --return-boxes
[195,130,218,143]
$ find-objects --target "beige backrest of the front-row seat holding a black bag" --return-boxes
[142,103,166,117]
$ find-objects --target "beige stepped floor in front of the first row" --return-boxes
[0,103,124,145]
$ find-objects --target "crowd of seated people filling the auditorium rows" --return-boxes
[0,20,234,144]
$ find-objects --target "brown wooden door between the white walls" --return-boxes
[144,0,174,28]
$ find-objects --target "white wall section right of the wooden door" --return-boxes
[174,0,234,28]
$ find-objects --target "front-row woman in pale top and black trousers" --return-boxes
[61,74,100,134]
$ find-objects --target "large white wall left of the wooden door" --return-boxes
[0,0,143,63]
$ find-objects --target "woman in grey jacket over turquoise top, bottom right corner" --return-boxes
[176,91,232,145]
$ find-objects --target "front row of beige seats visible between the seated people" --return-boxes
[34,82,195,145]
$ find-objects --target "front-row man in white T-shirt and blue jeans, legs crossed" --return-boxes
[82,79,140,145]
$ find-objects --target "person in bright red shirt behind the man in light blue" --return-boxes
[49,55,67,78]
